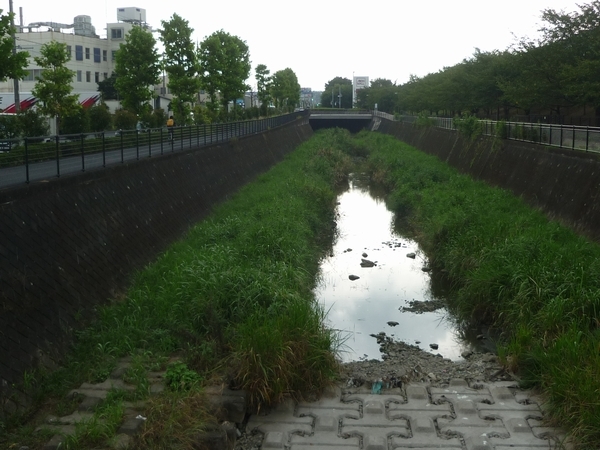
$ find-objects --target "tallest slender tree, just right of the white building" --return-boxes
[160,14,200,124]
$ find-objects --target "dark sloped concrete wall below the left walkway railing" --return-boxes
[0,118,312,416]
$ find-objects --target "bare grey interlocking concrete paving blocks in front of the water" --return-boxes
[247,380,563,450]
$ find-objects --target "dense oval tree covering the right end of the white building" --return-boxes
[115,26,160,114]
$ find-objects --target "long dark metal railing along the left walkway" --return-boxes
[0,112,304,189]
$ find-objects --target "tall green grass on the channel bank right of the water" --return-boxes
[360,130,600,448]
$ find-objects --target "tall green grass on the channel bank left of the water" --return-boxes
[0,131,352,449]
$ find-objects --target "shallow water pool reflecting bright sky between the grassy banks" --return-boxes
[316,176,476,361]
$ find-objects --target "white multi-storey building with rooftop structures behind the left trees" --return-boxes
[0,7,171,112]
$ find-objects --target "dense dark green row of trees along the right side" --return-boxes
[354,1,600,119]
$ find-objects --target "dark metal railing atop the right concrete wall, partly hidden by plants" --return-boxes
[374,111,600,153]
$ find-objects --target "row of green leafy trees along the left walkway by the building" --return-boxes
[0,10,300,132]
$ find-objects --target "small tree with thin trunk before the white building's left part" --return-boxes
[31,41,81,133]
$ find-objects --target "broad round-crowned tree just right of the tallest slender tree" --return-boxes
[198,30,250,117]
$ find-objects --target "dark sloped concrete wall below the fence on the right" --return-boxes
[379,120,600,242]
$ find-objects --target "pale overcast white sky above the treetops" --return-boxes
[8,0,589,91]
